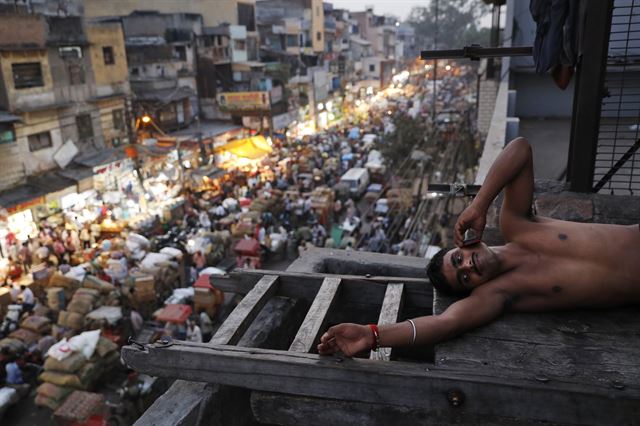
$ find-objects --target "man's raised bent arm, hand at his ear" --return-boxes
[454,138,533,246]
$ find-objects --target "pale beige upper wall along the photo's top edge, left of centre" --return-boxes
[85,0,256,27]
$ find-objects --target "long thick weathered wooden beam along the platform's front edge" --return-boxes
[122,342,640,424]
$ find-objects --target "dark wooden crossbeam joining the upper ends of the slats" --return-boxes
[212,269,433,312]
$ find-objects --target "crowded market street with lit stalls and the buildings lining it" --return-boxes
[0,0,496,426]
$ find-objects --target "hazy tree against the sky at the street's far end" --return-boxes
[409,0,490,49]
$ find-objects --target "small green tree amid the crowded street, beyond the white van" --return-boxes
[378,113,429,171]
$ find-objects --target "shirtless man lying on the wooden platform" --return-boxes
[318,138,640,356]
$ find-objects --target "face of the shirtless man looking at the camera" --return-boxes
[442,242,499,291]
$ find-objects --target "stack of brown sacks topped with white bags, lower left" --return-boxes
[36,330,120,410]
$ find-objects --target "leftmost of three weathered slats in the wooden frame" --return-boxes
[209,275,279,345]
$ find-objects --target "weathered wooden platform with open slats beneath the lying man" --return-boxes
[123,271,640,424]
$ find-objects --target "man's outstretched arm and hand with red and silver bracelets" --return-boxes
[318,288,509,356]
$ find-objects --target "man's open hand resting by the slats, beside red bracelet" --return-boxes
[318,323,375,356]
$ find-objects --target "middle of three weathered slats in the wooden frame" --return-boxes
[289,278,341,352]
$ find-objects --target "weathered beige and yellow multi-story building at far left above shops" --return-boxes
[0,8,130,233]
